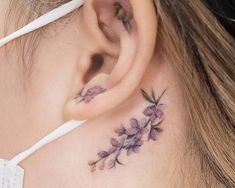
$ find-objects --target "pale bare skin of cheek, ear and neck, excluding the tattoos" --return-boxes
[0,0,200,188]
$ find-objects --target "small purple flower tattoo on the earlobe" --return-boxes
[75,86,106,103]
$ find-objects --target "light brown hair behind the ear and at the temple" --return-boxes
[4,0,235,188]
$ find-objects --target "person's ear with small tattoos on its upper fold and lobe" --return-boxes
[65,0,157,119]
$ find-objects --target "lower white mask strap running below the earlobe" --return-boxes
[9,120,86,165]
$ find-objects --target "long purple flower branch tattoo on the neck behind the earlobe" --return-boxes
[88,89,166,172]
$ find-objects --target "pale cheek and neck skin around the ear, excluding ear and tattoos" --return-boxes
[0,1,203,188]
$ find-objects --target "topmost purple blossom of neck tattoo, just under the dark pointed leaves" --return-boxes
[143,105,164,122]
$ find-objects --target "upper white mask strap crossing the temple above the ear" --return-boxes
[0,0,84,47]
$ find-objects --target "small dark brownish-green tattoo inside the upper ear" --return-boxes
[113,2,133,33]
